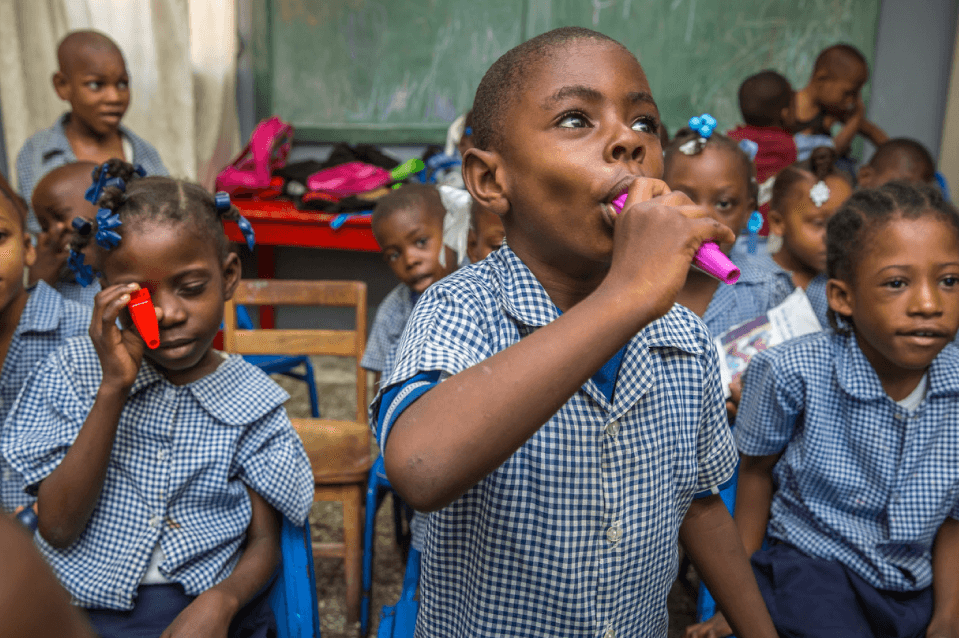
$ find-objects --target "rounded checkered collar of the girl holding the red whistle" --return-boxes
[130,355,290,426]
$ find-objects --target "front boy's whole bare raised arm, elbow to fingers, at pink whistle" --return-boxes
[384,179,732,511]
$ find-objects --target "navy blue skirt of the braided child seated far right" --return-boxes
[752,543,933,638]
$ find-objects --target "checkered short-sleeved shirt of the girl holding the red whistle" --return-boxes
[2,337,313,609]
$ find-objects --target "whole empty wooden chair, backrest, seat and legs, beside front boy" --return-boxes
[223,279,373,623]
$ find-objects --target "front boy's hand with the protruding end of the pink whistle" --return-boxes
[607,177,739,318]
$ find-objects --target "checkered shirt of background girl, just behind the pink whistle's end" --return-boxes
[703,255,795,337]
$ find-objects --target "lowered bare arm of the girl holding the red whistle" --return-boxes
[160,488,282,638]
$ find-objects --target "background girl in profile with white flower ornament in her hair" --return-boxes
[747,155,852,329]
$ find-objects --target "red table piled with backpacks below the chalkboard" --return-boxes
[224,198,380,328]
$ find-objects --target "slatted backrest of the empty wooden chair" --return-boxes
[223,279,367,423]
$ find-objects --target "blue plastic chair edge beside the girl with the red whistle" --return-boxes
[270,516,320,638]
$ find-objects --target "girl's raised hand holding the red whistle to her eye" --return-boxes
[90,284,144,389]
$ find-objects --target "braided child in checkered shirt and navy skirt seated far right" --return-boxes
[692,182,959,638]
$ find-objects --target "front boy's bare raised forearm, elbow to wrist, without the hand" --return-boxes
[384,286,655,511]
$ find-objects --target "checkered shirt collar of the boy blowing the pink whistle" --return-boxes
[488,243,705,355]
